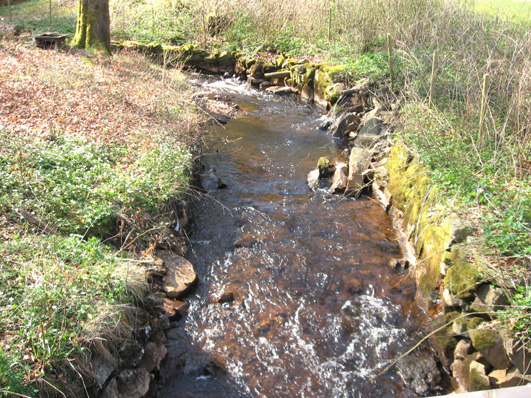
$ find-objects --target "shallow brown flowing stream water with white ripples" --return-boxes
[158,80,430,398]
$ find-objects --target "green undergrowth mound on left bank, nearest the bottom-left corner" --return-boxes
[0,235,147,395]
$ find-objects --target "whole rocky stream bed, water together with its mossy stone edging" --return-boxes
[80,44,531,397]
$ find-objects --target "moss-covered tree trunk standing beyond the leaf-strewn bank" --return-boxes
[72,0,111,54]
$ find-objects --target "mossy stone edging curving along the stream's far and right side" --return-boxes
[101,47,528,398]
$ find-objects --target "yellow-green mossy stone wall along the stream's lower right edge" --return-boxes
[379,144,531,392]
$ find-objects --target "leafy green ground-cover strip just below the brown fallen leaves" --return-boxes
[0,132,190,237]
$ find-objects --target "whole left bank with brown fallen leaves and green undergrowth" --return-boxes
[0,30,200,397]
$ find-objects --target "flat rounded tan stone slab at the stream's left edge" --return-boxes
[161,252,197,298]
